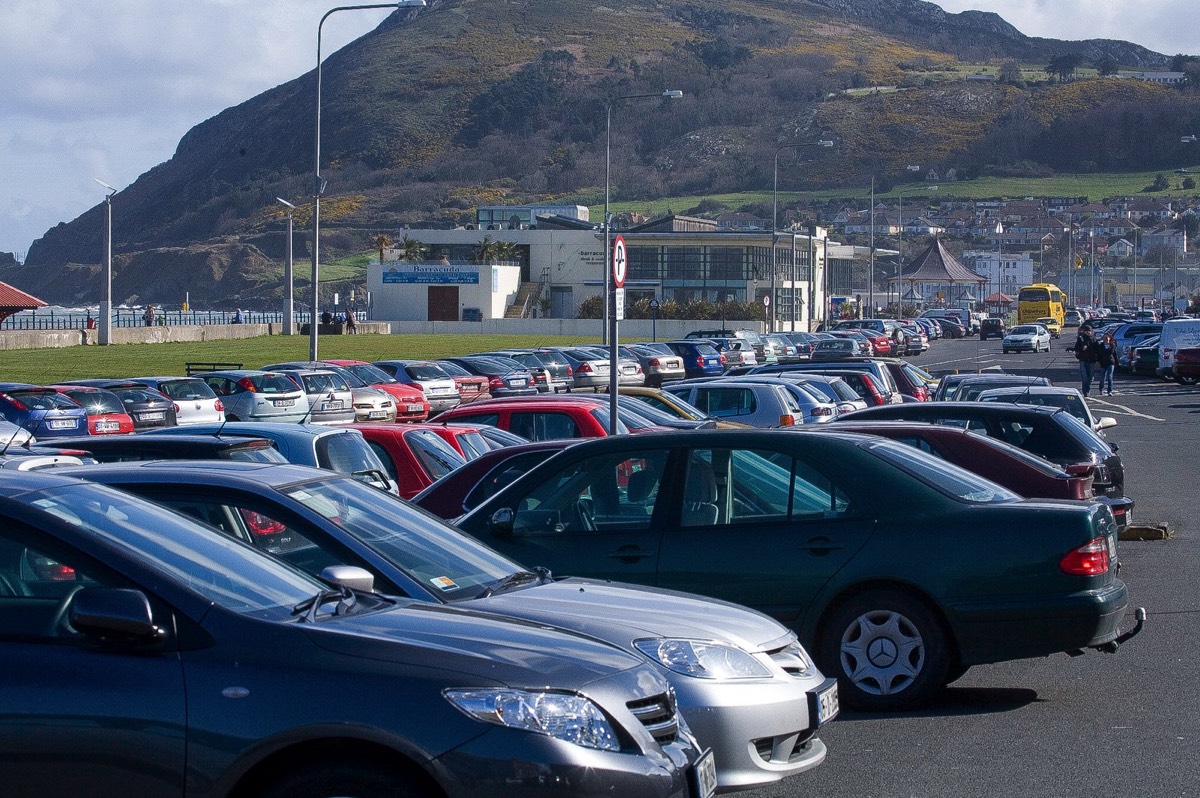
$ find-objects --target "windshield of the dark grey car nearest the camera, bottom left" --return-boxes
[32,485,328,616]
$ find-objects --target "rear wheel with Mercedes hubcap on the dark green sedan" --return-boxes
[817,590,950,712]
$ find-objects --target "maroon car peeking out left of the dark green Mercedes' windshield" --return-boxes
[413,438,575,520]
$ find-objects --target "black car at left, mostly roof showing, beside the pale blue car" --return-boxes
[55,431,288,463]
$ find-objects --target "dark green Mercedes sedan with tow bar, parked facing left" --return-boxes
[457,429,1142,710]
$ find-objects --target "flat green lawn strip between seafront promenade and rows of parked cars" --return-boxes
[0,335,599,385]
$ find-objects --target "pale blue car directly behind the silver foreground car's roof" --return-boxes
[149,421,398,493]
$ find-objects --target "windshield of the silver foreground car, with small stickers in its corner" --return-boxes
[281,479,524,600]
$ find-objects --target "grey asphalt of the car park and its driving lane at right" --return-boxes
[744,332,1200,798]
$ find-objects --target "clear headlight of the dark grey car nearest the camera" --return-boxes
[443,688,620,751]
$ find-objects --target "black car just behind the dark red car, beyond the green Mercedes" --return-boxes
[834,402,1124,497]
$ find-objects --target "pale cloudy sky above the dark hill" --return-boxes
[0,0,1200,260]
